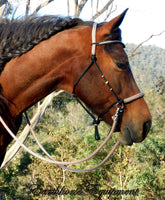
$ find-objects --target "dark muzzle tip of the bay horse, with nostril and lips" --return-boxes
[119,120,151,145]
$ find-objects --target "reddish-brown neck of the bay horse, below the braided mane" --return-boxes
[0,28,90,117]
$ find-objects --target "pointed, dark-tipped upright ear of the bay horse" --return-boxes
[100,8,128,36]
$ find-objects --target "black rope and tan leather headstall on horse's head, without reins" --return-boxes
[73,23,144,140]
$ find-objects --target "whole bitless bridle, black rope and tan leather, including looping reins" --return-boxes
[0,23,144,172]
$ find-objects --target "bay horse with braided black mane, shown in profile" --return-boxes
[0,10,151,164]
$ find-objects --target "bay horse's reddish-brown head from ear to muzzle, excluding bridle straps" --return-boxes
[68,10,151,145]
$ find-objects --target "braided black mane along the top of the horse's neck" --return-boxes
[0,16,84,73]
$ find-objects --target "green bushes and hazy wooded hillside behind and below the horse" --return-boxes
[0,44,165,200]
